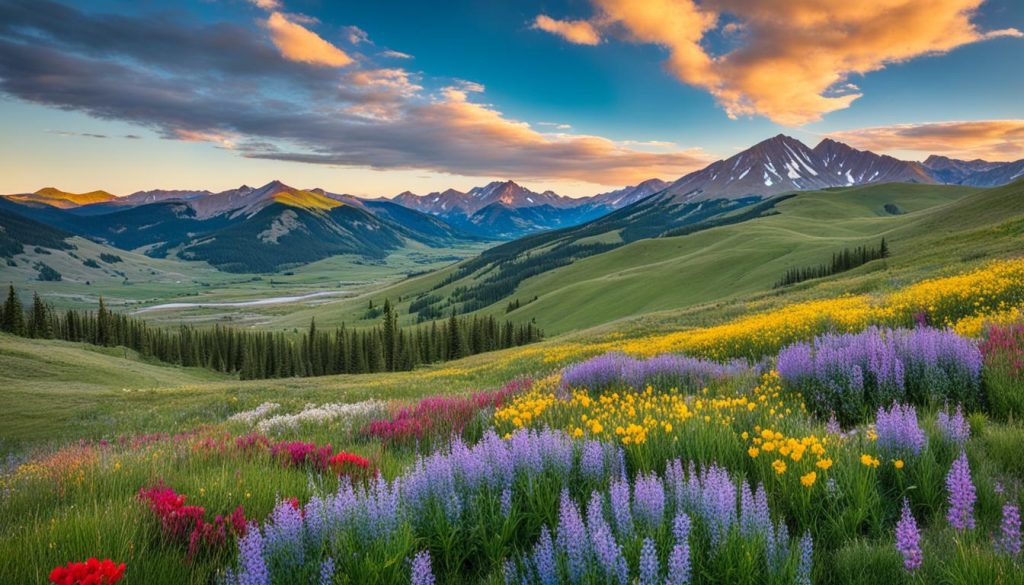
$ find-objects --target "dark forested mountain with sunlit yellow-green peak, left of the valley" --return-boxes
[5,181,475,273]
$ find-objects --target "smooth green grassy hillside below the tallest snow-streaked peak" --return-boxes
[264,182,1024,334]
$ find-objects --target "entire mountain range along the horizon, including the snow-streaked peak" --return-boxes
[0,134,1024,271]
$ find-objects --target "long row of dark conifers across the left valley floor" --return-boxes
[0,287,543,379]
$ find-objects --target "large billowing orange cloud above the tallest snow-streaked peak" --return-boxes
[545,0,1024,126]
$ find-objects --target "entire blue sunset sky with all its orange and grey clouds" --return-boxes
[0,0,1024,197]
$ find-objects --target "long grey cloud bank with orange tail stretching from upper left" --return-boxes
[0,0,710,185]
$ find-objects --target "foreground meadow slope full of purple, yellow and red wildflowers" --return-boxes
[6,260,1024,585]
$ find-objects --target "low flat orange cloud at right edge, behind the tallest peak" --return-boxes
[829,120,1024,161]
